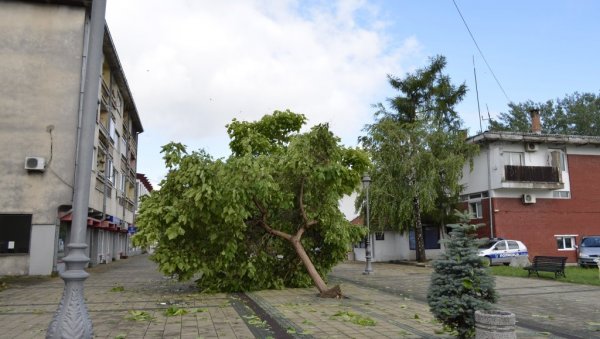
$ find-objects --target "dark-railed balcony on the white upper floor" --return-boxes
[502,165,565,190]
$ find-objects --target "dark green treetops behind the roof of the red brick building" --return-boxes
[489,92,600,136]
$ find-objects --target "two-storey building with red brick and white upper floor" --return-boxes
[462,116,600,263]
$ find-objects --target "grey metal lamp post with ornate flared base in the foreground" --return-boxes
[46,0,106,339]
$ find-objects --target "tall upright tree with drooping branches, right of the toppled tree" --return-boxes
[357,56,476,261]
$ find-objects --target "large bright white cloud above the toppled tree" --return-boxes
[107,0,419,149]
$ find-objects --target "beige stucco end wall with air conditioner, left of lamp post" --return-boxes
[0,1,85,274]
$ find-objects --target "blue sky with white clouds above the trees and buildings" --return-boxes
[106,0,600,218]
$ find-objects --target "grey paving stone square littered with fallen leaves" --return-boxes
[0,255,600,338]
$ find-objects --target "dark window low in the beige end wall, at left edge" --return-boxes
[0,214,31,253]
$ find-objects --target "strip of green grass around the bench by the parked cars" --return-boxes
[491,266,600,286]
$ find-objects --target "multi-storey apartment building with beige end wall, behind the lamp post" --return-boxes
[0,1,143,275]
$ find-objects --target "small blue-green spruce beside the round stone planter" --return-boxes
[427,211,497,338]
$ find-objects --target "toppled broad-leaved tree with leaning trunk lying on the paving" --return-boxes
[134,111,369,296]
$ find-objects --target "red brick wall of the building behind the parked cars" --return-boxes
[485,155,600,262]
